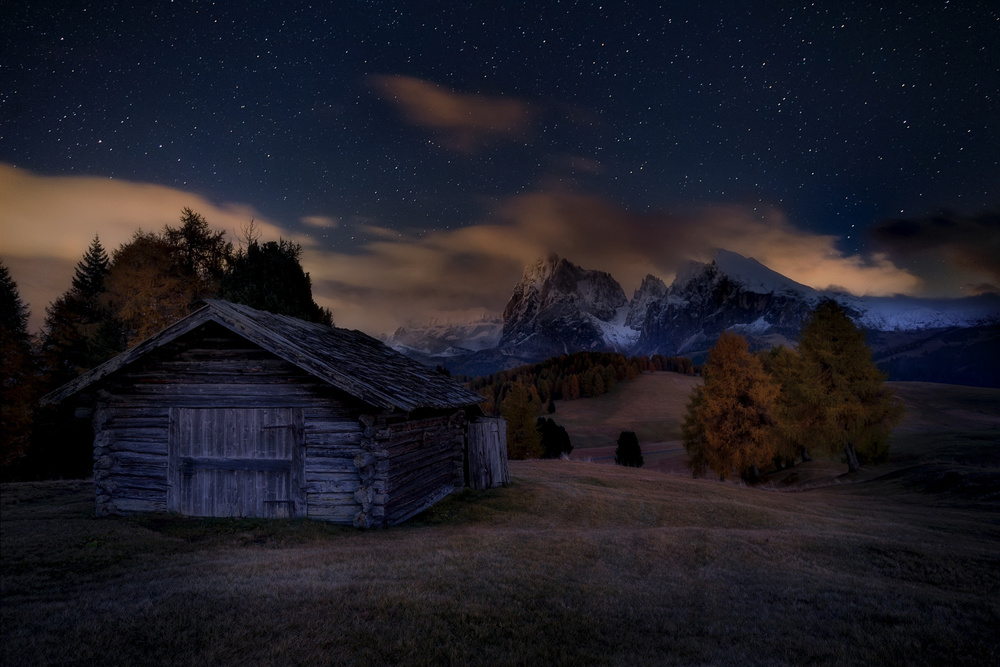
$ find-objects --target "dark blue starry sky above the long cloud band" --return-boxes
[0,0,1000,332]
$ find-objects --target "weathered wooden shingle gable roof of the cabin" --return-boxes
[42,299,483,412]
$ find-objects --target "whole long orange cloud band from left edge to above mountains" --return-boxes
[0,164,922,333]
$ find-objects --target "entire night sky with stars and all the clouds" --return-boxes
[0,0,1000,332]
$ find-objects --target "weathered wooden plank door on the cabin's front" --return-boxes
[167,408,305,518]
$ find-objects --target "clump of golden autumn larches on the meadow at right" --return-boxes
[682,299,903,480]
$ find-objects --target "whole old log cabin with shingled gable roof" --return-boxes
[43,300,507,527]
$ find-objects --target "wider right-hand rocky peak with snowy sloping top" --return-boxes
[636,261,818,356]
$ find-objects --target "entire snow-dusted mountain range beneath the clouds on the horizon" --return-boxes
[387,250,1000,386]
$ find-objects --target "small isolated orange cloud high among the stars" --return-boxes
[371,76,532,153]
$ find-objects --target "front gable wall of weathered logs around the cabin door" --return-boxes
[94,324,363,523]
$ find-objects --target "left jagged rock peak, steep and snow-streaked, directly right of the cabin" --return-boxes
[499,255,628,355]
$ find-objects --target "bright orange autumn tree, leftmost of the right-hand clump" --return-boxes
[682,332,778,479]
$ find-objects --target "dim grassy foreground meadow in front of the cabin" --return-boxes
[0,384,1000,666]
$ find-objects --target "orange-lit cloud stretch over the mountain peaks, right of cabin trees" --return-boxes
[305,193,921,331]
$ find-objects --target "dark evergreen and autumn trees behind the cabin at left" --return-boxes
[0,208,333,478]
